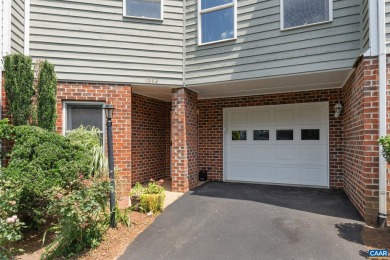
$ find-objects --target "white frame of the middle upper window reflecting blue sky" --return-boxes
[198,0,237,46]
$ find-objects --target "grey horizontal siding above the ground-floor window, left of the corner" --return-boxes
[30,0,183,86]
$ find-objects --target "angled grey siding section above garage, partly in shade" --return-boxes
[186,0,361,85]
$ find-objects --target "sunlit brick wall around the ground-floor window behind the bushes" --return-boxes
[56,82,131,195]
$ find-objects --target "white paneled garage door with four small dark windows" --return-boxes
[224,102,329,187]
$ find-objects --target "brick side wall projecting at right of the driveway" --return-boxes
[343,58,390,224]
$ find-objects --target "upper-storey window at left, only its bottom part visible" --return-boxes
[123,0,163,20]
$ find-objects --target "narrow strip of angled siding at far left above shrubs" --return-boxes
[10,0,24,53]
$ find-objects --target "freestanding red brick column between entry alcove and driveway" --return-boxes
[171,88,198,192]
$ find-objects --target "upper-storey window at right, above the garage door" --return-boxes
[281,0,333,29]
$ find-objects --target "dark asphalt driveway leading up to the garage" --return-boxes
[119,182,367,260]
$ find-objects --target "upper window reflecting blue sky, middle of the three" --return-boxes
[198,0,237,45]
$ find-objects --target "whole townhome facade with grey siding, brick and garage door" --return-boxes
[1,0,390,224]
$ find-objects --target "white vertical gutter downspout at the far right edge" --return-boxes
[377,0,387,228]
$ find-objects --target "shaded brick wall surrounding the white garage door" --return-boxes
[198,89,343,189]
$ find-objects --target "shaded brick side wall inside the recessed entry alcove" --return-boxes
[131,94,171,184]
